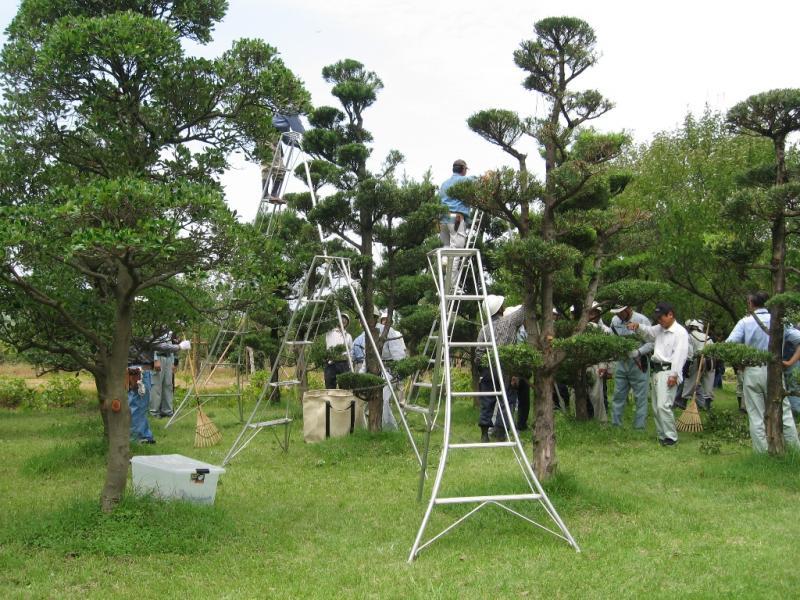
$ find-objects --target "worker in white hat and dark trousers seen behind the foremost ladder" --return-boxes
[475,295,525,443]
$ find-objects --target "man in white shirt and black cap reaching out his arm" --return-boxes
[628,302,689,446]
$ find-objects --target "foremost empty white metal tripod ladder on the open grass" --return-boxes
[408,248,580,562]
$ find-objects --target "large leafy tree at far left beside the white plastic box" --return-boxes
[0,0,308,510]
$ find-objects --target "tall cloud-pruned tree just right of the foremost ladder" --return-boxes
[449,17,643,478]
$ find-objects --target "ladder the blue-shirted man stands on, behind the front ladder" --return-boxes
[403,210,483,430]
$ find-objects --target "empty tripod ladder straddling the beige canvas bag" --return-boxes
[222,256,422,466]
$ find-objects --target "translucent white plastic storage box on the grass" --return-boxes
[131,454,225,504]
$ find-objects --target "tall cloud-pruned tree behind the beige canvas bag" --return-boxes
[296,59,440,431]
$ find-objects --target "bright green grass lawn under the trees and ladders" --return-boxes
[0,386,800,598]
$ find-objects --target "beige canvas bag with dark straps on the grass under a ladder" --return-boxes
[303,390,366,442]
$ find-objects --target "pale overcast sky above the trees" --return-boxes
[0,0,800,218]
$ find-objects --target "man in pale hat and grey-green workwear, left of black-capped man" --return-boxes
[610,304,653,429]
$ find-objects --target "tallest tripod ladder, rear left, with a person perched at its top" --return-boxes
[165,131,322,427]
